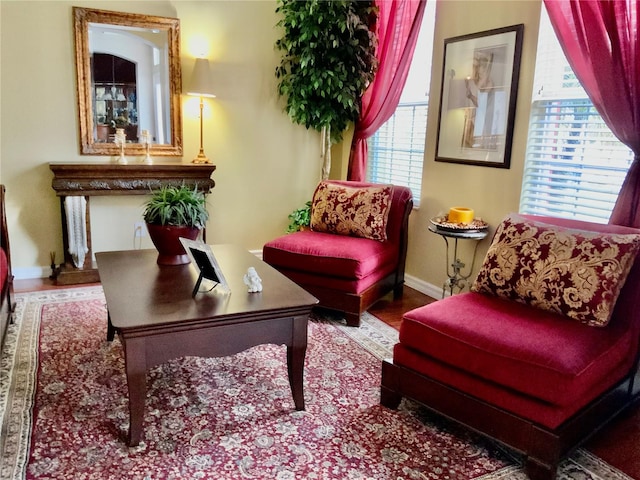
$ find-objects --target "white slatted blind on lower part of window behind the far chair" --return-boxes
[367,102,427,208]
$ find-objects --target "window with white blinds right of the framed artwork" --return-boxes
[520,8,633,223]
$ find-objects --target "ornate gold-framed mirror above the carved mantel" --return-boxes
[73,7,182,156]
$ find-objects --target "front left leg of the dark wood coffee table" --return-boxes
[123,338,147,447]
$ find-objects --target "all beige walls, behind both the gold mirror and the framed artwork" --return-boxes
[0,0,540,296]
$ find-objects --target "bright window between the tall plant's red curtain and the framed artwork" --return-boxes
[367,0,436,208]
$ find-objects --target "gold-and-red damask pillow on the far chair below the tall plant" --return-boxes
[311,181,393,241]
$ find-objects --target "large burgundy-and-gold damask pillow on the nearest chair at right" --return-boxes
[472,214,640,326]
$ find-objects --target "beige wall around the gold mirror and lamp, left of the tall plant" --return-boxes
[0,0,321,275]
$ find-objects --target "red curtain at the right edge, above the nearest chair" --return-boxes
[545,0,640,228]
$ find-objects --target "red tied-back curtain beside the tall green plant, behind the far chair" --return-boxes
[347,0,426,181]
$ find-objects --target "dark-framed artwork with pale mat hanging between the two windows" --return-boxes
[435,24,524,168]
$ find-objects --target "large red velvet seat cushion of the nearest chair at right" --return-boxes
[394,292,636,405]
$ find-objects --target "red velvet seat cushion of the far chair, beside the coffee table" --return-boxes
[262,231,398,280]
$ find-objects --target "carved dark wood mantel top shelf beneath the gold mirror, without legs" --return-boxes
[49,162,216,197]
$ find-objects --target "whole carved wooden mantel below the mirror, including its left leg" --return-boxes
[49,162,216,285]
